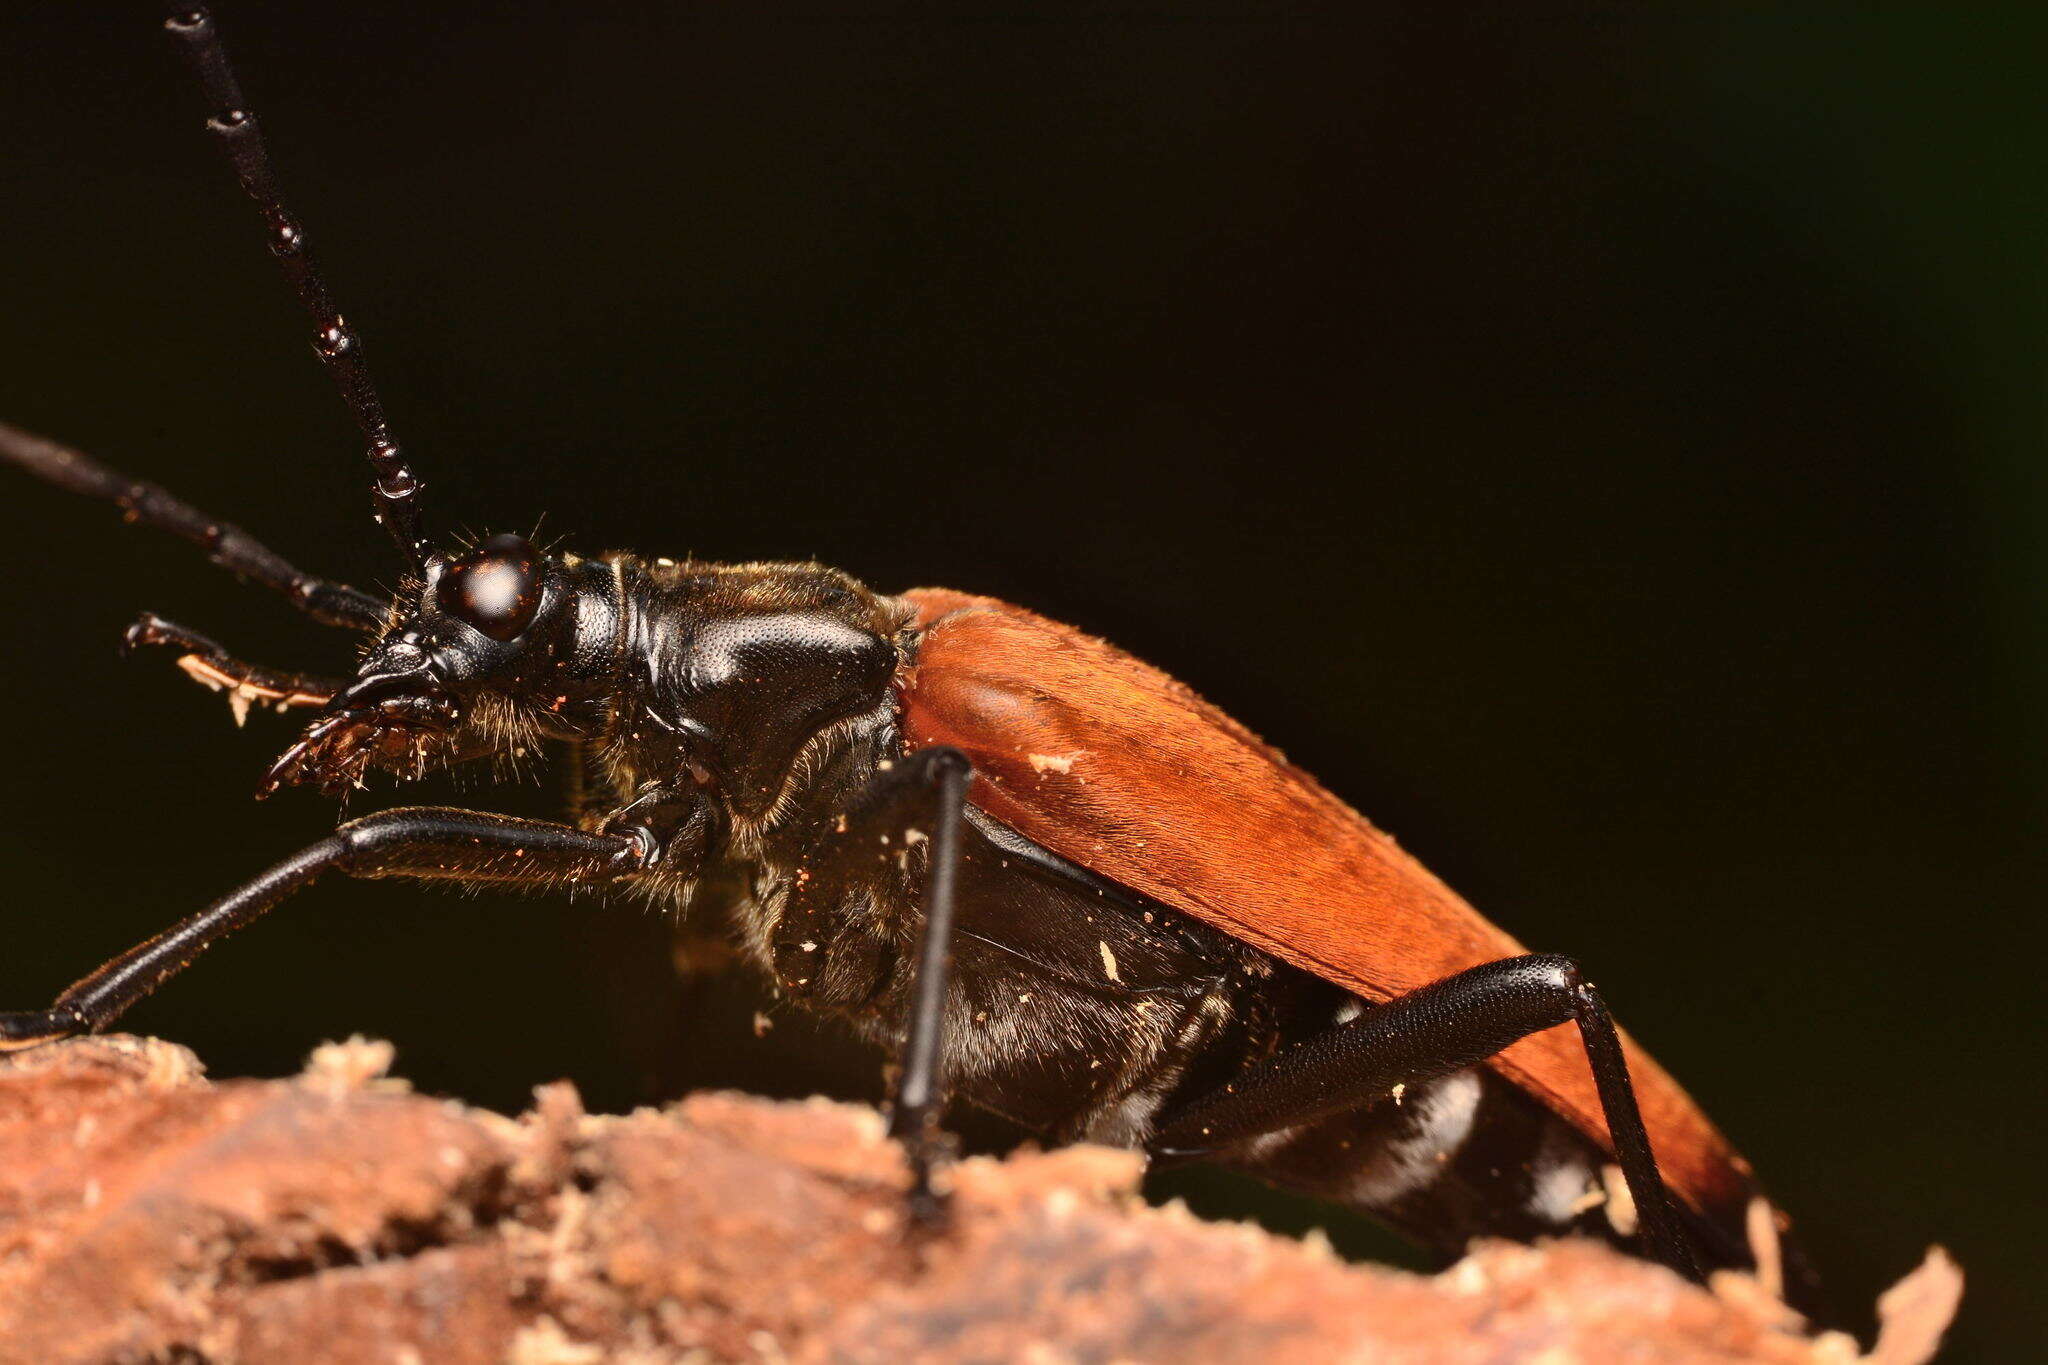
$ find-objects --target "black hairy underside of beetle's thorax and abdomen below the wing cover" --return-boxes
[737,773,1654,1254]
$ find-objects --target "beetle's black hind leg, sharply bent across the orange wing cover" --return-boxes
[1149,956,1700,1279]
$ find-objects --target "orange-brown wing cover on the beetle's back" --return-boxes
[901,587,1753,1228]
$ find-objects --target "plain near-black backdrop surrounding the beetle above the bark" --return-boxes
[0,2,2048,1359]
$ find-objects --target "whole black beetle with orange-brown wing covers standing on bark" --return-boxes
[0,8,1806,1289]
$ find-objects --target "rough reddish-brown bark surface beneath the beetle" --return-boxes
[0,1038,1960,1365]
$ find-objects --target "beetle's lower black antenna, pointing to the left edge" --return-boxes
[0,422,389,630]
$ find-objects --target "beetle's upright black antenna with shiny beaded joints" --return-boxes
[164,4,428,569]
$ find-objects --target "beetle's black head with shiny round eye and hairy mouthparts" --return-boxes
[258,534,612,794]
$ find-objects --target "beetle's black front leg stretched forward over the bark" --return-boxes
[0,806,647,1052]
